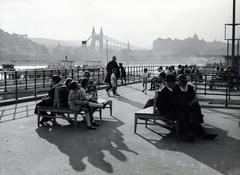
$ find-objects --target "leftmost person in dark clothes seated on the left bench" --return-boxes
[34,75,61,124]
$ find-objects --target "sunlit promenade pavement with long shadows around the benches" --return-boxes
[0,84,240,175]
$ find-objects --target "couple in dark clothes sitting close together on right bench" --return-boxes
[144,74,217,141]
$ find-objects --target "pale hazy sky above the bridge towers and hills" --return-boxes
[0,0,240,48]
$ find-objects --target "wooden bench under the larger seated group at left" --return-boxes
[37,86,112,128]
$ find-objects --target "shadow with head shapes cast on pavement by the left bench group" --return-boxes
[36,118,137,173]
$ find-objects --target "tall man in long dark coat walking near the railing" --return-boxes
[105,56,120,96]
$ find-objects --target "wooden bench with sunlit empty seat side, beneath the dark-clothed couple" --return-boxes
[134,91,179,136]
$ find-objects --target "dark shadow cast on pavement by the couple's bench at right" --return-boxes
[138,125,240,174]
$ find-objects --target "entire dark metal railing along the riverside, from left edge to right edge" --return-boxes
[0,65,240,105]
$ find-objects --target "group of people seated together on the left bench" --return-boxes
[34,71,109,130]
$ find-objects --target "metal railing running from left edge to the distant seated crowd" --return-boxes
[0,66,154,101]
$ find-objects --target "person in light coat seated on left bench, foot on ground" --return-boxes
[68,81,96,130]
